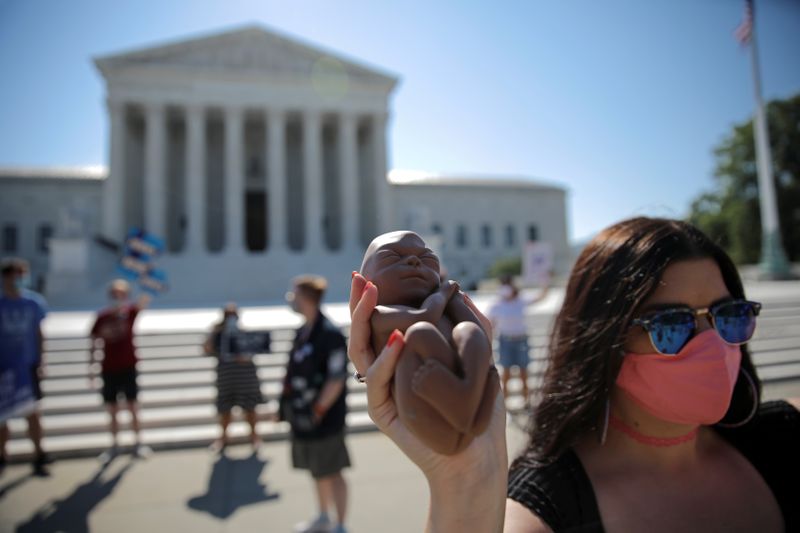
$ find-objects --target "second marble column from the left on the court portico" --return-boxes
[144,104,166,239]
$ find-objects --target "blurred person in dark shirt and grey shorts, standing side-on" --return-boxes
[280,275,350,533]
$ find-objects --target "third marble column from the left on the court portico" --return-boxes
[185,105,207,253]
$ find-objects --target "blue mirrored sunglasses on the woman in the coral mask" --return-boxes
[633,300,761,355]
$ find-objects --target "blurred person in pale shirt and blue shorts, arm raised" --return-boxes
[486,276,549,405]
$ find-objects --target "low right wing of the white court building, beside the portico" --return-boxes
[389,170,570,287]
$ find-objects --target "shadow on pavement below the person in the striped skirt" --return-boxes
[186,453,280,519]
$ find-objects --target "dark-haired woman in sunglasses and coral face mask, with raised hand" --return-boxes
[350,218,800,531]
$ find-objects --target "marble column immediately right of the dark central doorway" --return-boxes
[267,110,288,252]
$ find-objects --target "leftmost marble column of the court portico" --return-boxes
[103,100,128,243]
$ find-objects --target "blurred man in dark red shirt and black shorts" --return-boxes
[89,279,151,463]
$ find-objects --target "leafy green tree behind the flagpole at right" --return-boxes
[689,94,800,263]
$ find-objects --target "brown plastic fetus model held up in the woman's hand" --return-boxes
[361,231,499,455]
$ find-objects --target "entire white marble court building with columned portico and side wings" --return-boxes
[0,27,568,306]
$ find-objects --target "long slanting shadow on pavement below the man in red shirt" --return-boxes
[17,460,134,533]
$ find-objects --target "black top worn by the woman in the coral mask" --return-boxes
[508,401,800,532]
